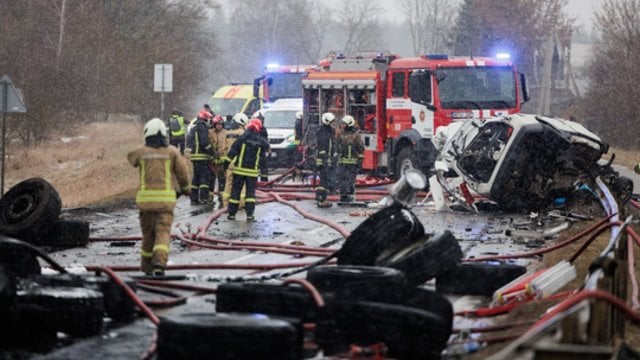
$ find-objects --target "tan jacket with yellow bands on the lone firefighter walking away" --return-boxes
[127,146,191,212]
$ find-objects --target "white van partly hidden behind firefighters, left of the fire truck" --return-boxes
[263,98,302,167]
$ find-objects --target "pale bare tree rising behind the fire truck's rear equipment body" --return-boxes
[337,0,383,54]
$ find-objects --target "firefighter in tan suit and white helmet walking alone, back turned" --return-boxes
[127,118,191,276]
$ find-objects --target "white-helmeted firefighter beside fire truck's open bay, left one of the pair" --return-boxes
[315,112,337,208]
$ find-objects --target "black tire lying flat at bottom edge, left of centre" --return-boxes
[157,312,302,360]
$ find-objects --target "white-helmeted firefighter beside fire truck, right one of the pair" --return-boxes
[336,115,364,202]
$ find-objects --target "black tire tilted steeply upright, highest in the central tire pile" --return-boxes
[337,204,424,266]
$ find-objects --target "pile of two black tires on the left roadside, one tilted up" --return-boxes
[0,178,90,248]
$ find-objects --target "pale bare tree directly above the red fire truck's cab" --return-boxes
[400,0,460,56]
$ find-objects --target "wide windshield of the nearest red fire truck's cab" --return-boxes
[436,67,516,109]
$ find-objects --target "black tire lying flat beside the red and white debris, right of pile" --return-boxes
[436,263,527,296]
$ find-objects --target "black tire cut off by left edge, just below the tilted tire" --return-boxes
[0,236,41,277]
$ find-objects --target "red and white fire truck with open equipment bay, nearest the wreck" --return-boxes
[302,52,529,178]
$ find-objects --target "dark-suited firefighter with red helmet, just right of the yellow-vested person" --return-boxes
[187,110,214,205]
